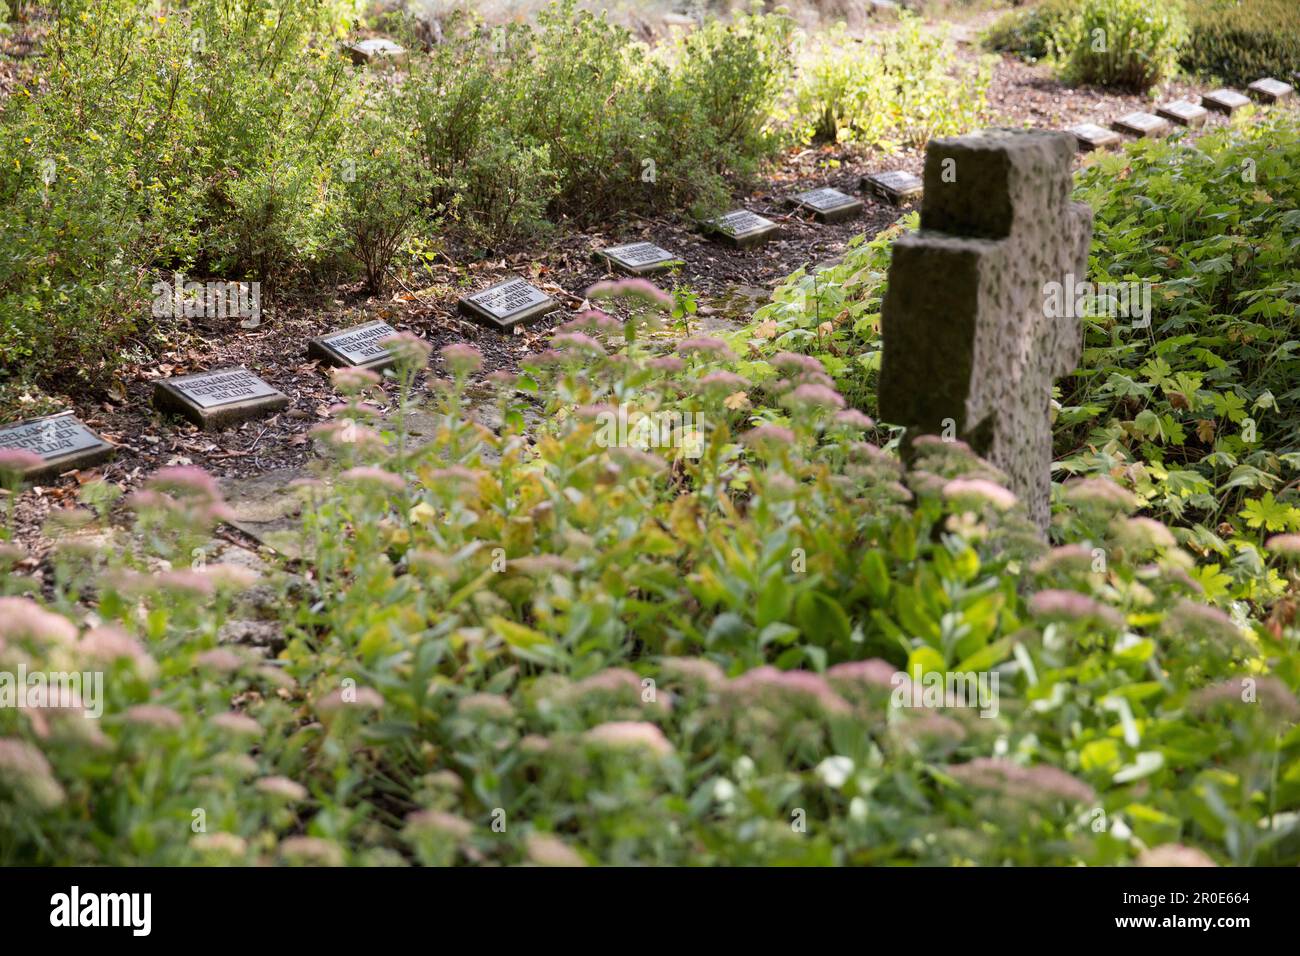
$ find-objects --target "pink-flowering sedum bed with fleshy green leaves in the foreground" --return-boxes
[0,254,1300,865]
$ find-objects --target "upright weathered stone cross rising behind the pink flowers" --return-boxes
[880,130,1092,528]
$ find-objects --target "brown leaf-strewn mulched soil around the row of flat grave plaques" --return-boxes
[0,14,1294,556]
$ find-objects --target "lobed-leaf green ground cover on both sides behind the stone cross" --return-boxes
[742,111,1300,606]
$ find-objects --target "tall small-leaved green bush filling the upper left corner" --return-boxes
[0,0,351,395]
